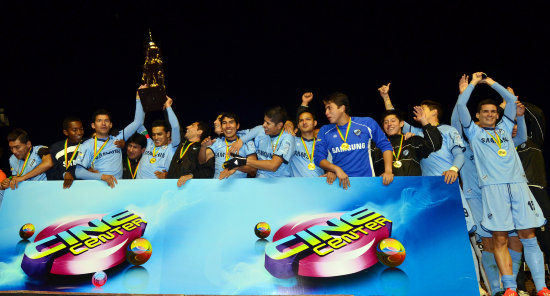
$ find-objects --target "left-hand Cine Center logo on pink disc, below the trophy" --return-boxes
[21,210,147,276]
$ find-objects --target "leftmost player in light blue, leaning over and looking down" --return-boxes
[1,128,53,190]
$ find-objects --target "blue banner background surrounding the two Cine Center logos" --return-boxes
[0,177,479,295]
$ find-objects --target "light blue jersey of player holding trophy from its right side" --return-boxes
[136,107,181,179]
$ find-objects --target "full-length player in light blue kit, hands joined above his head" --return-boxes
[457,72,550,296]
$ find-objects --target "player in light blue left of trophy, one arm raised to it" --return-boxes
[76,86,149,188]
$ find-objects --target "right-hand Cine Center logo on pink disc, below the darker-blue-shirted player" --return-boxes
[265,207,392,278]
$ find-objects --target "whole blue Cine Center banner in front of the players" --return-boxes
[0,177,479,295]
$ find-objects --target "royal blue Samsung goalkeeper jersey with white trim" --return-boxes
[314,117,393,177]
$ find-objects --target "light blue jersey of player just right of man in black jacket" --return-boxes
[403,124,464,176]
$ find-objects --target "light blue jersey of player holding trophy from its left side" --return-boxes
[76,100,145,180]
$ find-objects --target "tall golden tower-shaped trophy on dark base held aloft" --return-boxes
[138,30,166,112]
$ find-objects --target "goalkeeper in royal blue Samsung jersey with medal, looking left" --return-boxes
[314,92,393,189]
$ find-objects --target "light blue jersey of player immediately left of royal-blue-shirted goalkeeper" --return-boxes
[290,137,325,177]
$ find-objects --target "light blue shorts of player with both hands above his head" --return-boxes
[481,183,546,231]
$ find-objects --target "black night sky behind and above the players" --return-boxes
[0,1,550,178]
